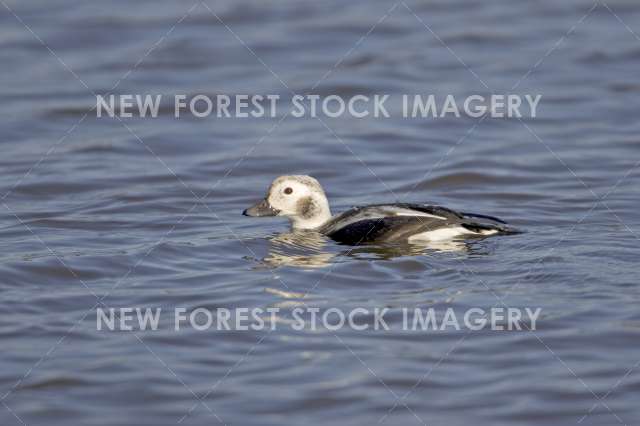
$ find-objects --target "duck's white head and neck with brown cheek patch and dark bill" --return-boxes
[242,175,331,229]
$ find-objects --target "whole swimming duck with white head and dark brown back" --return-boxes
[242,175,519,245]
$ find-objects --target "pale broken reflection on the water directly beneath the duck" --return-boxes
[262,231,476,268]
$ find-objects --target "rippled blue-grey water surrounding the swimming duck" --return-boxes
[0,0,640,426]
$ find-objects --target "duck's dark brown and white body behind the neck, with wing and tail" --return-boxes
[321,203,516,244]
